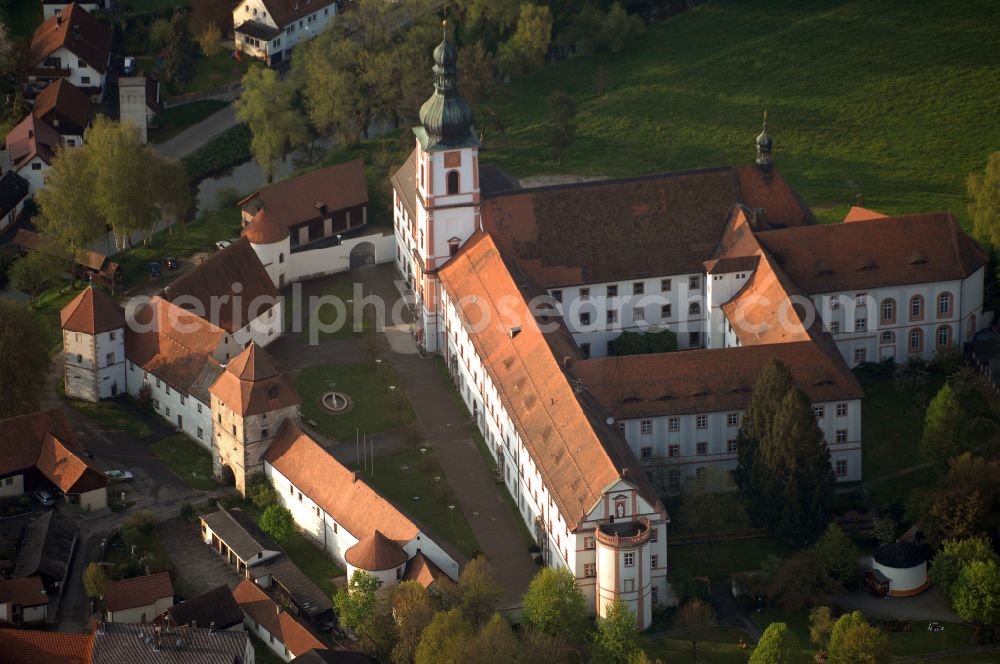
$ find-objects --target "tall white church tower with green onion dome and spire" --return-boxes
[412,22,479,351]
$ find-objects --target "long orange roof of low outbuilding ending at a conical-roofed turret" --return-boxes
[264,420,420,546]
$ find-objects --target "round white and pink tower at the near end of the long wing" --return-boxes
[594,517,653,629]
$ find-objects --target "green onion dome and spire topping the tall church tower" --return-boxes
[414,22,479,150]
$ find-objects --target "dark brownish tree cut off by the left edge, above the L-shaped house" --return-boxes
[0,298,49,419]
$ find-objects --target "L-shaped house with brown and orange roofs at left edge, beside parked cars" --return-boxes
[0,408,108,510]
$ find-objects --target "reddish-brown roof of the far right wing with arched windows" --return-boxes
[757,212,986,294]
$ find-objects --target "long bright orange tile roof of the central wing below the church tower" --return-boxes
[438,234,662,530]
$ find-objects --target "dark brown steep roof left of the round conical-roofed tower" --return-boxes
[160,238,280,333]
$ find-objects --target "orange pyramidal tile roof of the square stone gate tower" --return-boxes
[209,342,302,417]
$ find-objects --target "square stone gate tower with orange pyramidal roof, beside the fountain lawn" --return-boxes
[208,343,302,495]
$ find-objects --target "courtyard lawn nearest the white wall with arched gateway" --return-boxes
[285,275,375,343]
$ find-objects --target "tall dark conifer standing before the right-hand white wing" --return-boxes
[759,387,836,538]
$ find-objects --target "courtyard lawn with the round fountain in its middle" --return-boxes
[295,362,414,445]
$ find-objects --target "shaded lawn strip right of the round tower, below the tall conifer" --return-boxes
[668,538,792,582]
